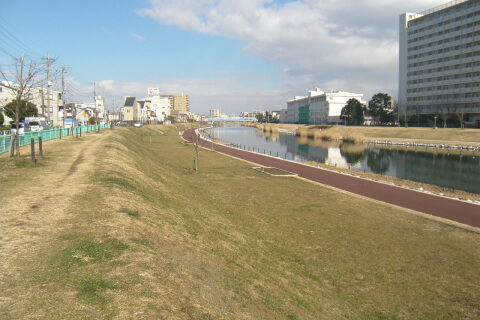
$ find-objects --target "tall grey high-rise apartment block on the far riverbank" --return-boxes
[398,0,480,125]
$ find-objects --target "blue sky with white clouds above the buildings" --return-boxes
[0,0,445,115]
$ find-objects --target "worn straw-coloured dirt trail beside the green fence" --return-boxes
[0,131,110,301]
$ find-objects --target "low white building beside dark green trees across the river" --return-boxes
[287,88,365,124]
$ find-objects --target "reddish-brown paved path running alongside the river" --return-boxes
[183,129,480,228]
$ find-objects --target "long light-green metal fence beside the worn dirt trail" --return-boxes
[0,124,110,154]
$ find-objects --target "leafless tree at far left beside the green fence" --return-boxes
[0,53,45,157]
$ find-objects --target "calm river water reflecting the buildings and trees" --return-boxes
[208,126,480,194]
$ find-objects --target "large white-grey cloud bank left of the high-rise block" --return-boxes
[137,0,439,112]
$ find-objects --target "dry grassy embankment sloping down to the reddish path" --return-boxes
[0,126,480,319]
